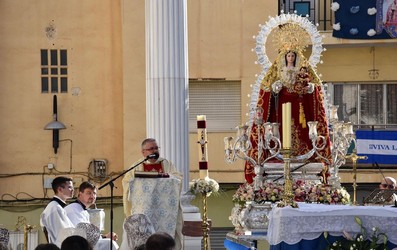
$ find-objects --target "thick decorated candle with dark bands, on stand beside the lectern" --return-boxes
[197,115,208,179]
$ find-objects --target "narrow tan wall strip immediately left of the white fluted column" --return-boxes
[119,0,146,170]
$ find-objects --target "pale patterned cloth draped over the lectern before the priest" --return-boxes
[128,177,182,236]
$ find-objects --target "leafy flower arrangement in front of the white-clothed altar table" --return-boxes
[324,216,387,250]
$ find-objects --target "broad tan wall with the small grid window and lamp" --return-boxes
[0,0,123,198]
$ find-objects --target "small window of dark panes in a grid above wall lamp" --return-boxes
[40,49,68,93]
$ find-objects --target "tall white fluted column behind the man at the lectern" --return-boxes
[146,0,189,191]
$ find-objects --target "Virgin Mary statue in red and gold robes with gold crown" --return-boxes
[245,23,331,183]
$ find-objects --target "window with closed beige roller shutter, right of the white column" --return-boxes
[189,80,241,132]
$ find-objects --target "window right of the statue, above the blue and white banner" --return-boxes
[333,83,397,125]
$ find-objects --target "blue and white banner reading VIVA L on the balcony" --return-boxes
[356,130,397,164]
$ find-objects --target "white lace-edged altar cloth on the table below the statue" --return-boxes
[267,203,397,245]
